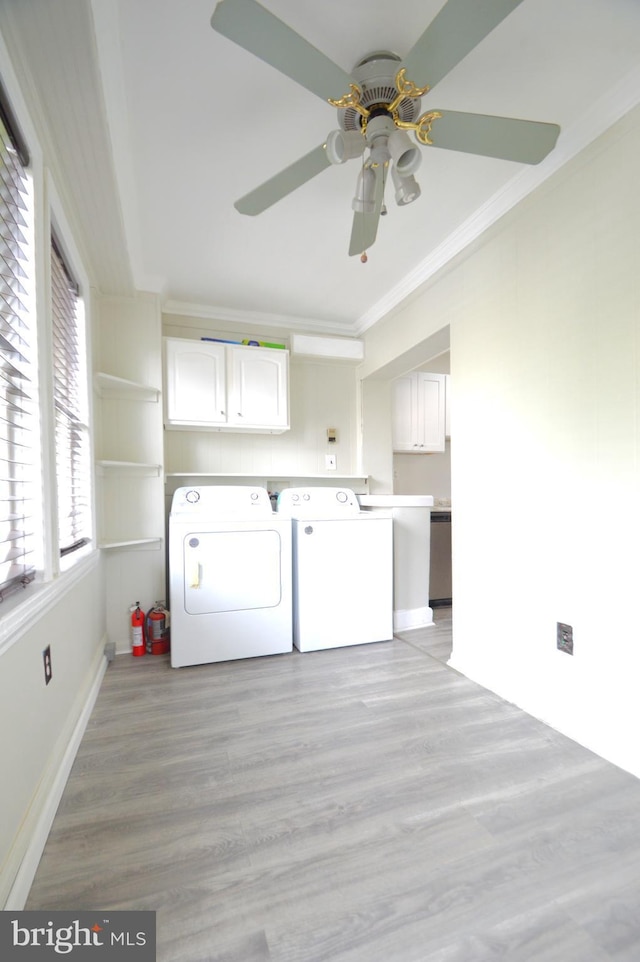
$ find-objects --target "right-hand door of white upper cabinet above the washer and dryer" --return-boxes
[228,346,289,429]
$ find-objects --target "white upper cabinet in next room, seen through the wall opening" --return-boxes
[393,371,445,454]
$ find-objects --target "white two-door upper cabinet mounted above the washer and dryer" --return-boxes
[165,337,289,433]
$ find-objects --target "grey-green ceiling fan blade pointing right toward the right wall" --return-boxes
[430,110,560,164]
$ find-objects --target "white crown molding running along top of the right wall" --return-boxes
[354,61,640,337]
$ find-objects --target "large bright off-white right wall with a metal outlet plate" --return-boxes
[367,103,640,775]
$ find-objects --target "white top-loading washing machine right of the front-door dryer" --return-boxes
[278,487,393,651]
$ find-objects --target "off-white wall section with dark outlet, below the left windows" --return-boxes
[0,555,106,908]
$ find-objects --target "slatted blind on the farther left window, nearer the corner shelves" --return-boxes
[51,238,91,555]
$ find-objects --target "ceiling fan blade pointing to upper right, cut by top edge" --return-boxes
[402,0,522,87]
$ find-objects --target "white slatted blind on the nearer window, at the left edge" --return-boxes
[0,101,39,599]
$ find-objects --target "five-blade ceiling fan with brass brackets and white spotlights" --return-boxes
[211,0,560,261]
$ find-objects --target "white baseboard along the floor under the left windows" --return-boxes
[4,655,107,911]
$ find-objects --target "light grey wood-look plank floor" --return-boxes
[27,610,640,962]
